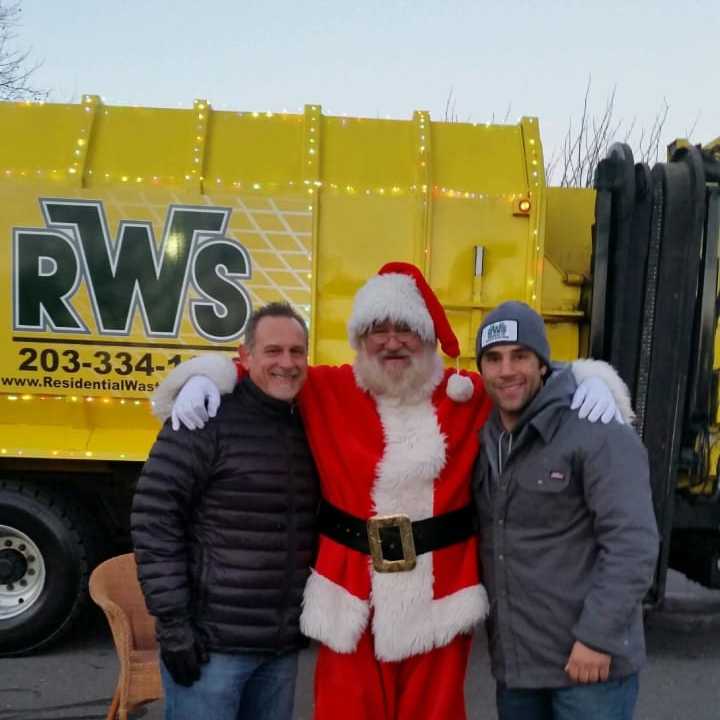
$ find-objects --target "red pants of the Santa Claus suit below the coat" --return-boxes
[315,630,471,720]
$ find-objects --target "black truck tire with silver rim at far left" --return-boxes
[0,480,97,656]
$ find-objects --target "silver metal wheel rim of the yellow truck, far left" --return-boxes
[0,525,45,620]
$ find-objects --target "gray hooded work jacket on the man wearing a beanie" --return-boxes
[473,368,658,688]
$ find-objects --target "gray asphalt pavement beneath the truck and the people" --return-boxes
[0,573,720,720]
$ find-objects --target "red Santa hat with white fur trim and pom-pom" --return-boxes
[348,262,473,402]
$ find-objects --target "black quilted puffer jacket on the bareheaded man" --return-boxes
[132,378,318,653]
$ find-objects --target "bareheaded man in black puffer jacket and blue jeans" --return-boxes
[132,303,318,720]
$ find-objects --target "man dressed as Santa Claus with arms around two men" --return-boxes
[155,263,629,720]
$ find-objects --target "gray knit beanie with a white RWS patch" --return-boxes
[475,300,550,366]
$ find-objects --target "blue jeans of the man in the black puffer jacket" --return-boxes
[160,652,298,720]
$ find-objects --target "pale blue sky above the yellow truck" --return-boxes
[20,0,720,173]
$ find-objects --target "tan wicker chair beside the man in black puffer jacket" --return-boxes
[90,553,163,720]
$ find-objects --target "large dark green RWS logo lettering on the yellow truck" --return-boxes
[13,199,251,341]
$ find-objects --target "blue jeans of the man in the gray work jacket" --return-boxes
[497,674,638,720]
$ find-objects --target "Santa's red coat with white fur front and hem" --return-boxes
[298,365,491,660]
